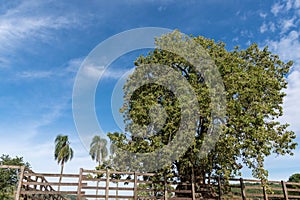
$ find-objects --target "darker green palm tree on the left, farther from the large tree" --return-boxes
[54,135,74,191]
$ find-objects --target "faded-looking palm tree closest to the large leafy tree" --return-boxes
[90,135,108,199]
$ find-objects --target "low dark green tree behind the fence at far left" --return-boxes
[0,155,30,199]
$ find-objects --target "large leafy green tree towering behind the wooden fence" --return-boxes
[108,31,296,183]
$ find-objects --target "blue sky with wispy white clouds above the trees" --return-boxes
[0,0,300,180]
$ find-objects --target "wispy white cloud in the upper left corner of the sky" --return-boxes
[0,0,84,65]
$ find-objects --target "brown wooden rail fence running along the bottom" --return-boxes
[0,166,300,200]
